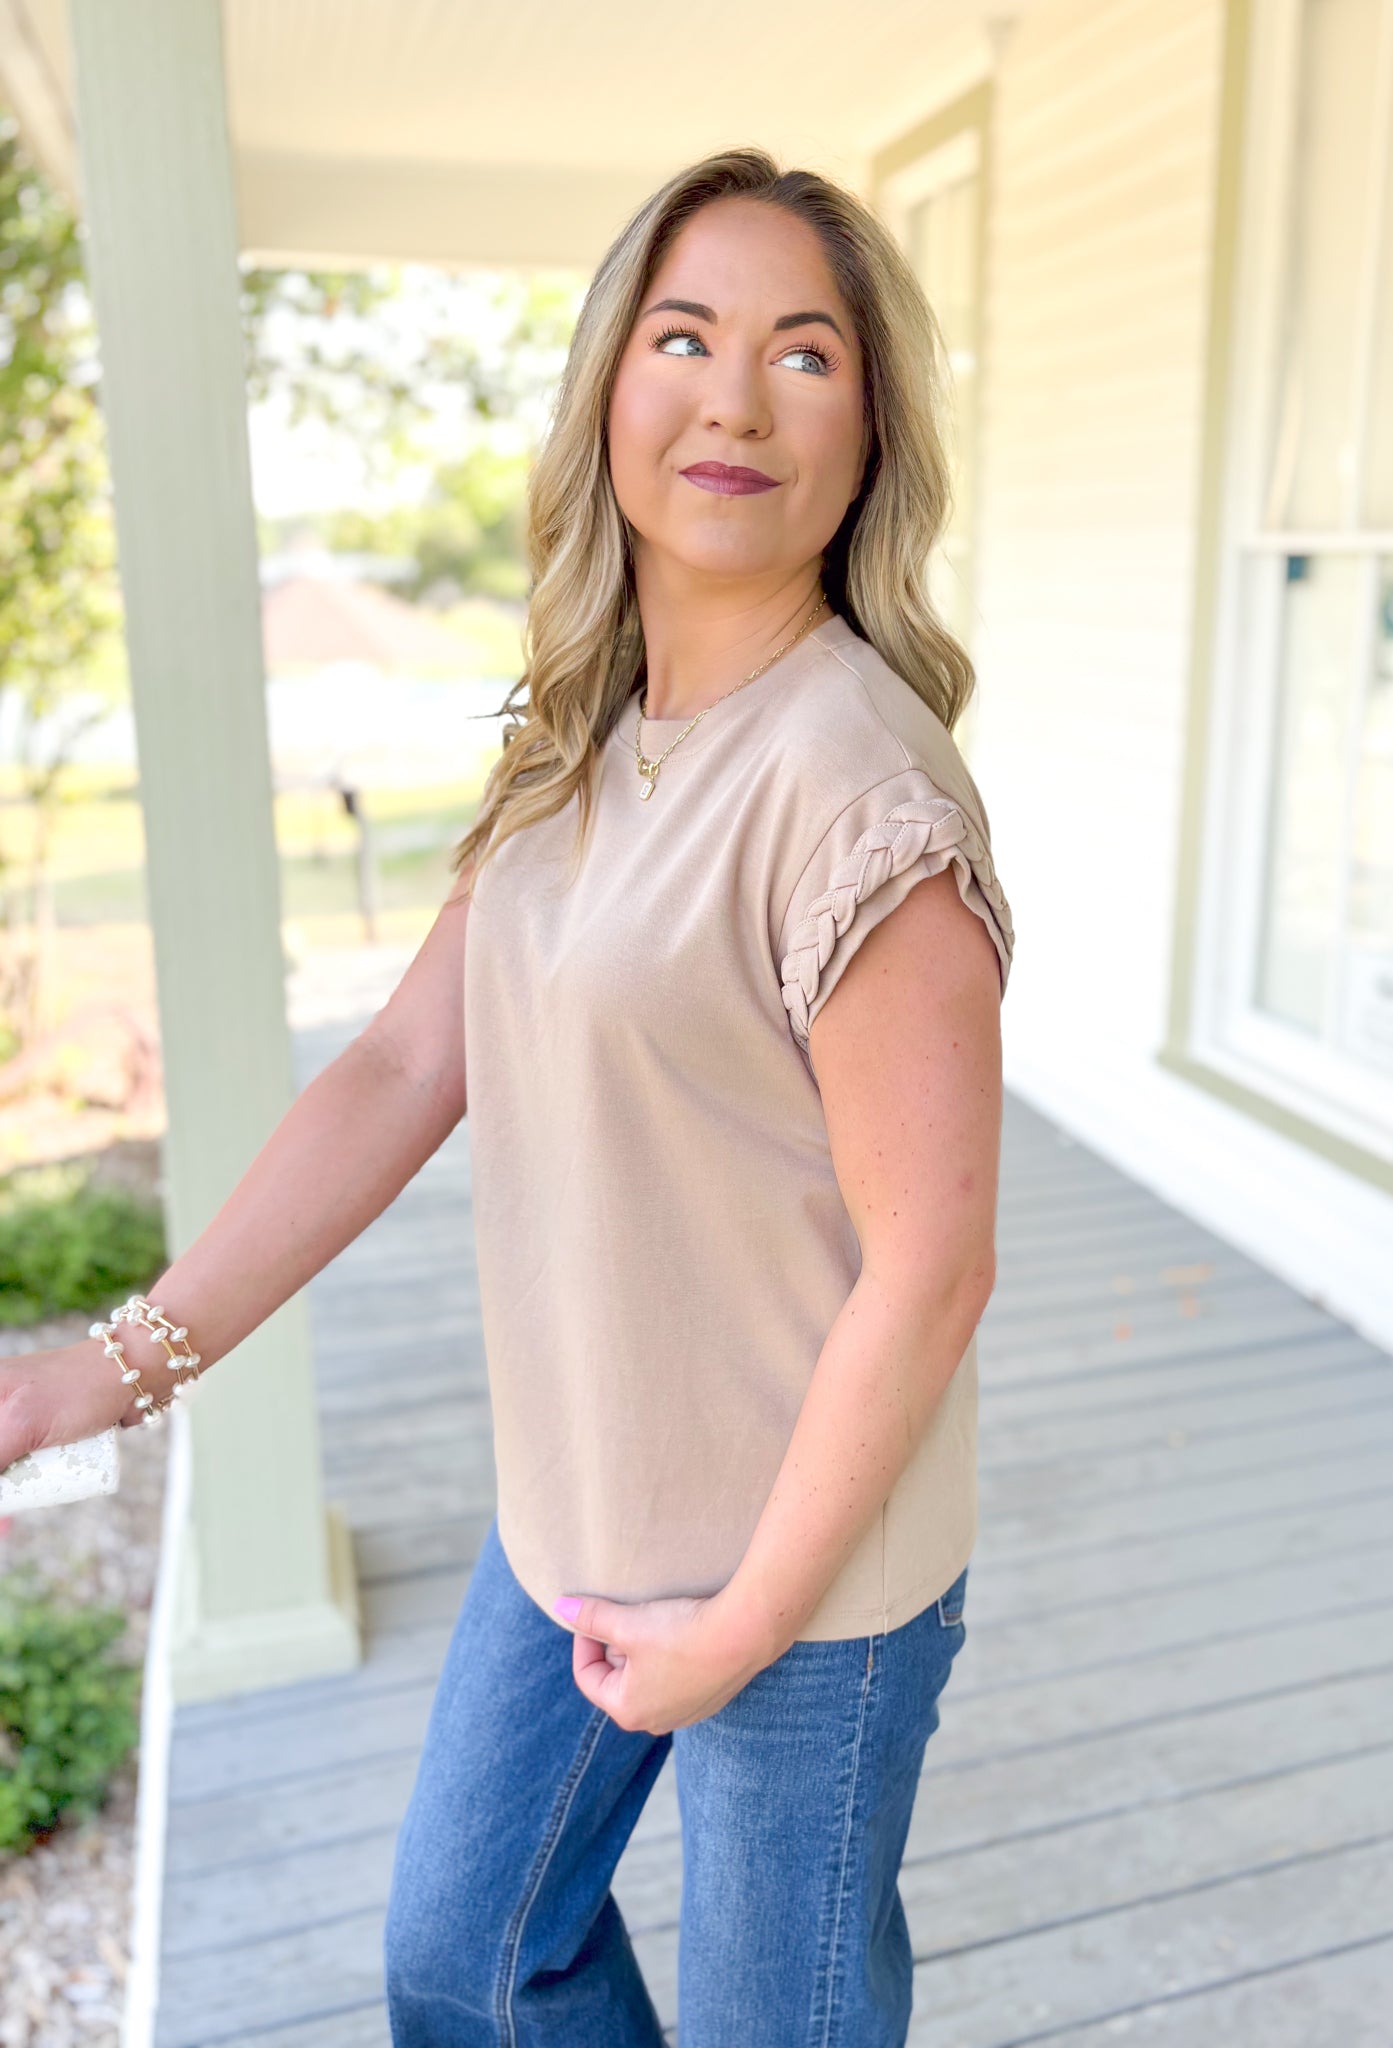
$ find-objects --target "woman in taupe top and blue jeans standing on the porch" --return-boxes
[0,150,1012,2048]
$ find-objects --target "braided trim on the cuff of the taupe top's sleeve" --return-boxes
[780,797,1014,1051]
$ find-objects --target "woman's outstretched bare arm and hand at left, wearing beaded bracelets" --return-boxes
[0,856,469,1470]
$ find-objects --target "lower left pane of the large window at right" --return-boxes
[1256,555,1366,1034]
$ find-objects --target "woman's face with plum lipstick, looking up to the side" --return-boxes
[608,199,864,582]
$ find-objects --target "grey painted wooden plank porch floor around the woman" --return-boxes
[156,958,1393,2048]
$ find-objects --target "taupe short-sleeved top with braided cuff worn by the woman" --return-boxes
[465,616,1014,1640]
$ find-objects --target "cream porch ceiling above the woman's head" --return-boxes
[0,0,1030,266]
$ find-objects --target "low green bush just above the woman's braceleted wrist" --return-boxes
[0,1165,164,1327]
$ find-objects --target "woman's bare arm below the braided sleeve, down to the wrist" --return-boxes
[717,868,1002,1657]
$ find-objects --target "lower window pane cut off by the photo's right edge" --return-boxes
[1338,559,1393,1073]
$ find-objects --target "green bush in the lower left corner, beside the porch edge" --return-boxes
[0,1583,141,1853]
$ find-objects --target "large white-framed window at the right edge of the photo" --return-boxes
[1194,0,1393,1159]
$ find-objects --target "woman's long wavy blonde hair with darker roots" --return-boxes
[451,150,975,897]
